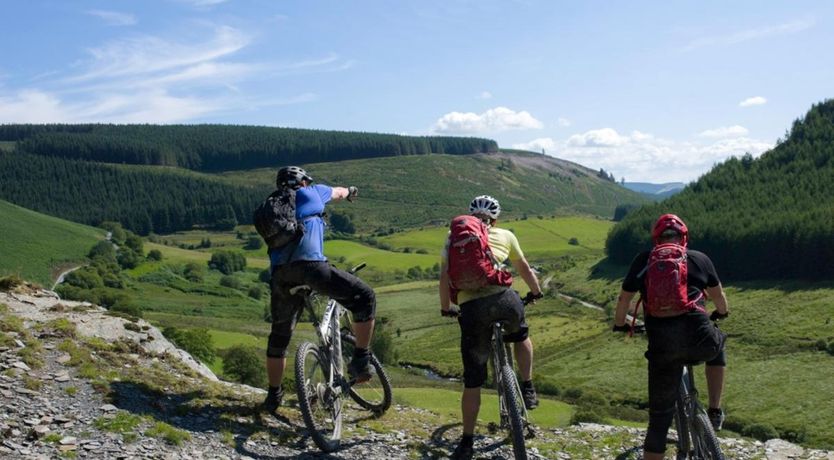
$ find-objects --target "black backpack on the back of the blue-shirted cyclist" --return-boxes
[252,187,304,249]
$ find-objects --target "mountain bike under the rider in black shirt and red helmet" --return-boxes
[675,363,724,460]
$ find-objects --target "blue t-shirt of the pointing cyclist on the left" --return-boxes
[269,184,333,269]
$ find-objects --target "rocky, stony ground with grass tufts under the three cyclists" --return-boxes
[0,286,834,460]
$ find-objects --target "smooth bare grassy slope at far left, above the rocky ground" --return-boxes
[0,200,104,287]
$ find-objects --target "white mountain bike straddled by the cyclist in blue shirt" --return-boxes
[289,263,391,452]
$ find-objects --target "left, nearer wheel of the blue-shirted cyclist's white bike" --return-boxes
[295,342,342,452]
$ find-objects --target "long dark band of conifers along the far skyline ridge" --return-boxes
[0,124,498,172]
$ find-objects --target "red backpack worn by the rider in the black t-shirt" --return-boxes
[643,243,703,316]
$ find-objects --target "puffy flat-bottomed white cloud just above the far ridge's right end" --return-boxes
[431,107,543,134]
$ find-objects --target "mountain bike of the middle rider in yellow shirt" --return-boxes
[490,298,535,460]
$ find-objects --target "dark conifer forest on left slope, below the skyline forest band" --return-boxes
[0,152,262,235]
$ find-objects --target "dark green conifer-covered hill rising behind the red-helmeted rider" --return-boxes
[606,100,834,280]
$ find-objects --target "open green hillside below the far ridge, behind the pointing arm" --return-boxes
[222,153,648,233]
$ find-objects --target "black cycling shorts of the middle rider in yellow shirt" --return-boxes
[458,289,529,388]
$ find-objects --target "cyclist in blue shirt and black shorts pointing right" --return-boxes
[264,166,376,412]
